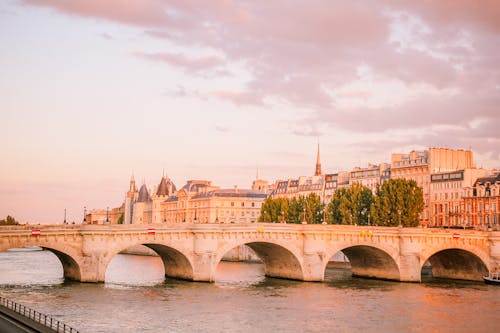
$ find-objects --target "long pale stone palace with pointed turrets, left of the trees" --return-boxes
[118,176,268,224]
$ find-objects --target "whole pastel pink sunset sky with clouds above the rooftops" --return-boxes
[0,0,500,223]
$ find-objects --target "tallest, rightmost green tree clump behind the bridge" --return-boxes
[371,179,424,227]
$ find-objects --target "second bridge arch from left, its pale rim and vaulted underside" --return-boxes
[102,242,194,280]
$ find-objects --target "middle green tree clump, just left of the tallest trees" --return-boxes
[327,183,373,225]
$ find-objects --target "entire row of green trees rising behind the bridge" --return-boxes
[259,179,424,227]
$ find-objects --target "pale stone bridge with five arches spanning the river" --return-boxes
[0,223,500,282]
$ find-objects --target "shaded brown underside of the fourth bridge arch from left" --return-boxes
[334,245,400,281]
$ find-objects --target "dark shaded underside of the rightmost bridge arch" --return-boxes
[420,248,488,281]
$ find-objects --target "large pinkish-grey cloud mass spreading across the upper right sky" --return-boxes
[21,0,500,160]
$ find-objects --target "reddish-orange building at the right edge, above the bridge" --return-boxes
[461,172,500,229]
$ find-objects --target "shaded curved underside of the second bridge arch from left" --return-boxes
[106,243,193,280]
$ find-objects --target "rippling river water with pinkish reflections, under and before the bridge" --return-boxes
[0,249,500,333]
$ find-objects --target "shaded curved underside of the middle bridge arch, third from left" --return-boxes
[214,241,304,281]
